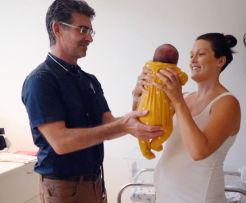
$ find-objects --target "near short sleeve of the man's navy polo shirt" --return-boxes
[22,72,65,128]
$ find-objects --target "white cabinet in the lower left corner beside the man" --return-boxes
[0,156,39,203]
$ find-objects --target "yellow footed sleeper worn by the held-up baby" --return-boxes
[137,61,188,159]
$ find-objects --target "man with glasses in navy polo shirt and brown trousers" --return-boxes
[22,0,162,203]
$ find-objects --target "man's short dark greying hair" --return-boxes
[46,0,95,46]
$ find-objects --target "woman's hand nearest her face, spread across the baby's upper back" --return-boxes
[154,68,184,108]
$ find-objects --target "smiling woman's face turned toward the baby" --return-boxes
[190,40,221,81]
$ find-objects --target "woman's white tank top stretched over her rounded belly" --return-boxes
[154,92,236,203]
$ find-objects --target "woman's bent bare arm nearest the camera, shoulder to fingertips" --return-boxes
[155,70,241,160]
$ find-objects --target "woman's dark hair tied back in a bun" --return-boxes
[197,33,237,72]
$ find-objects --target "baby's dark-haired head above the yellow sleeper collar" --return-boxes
[153,44,179,64]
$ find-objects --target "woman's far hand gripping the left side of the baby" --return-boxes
[132,66,153,110]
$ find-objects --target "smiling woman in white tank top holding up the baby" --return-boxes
[133,33,241,203]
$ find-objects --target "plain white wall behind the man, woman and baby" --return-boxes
[0,0,246,203]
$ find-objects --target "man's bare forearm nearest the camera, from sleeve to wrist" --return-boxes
[40,119,126,154]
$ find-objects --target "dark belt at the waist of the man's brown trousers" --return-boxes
[42,174,100,182]
